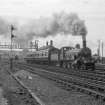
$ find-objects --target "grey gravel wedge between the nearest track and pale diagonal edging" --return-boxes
[15,70,105,105]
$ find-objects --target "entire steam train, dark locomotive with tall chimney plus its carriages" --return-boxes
[24,40,95,70]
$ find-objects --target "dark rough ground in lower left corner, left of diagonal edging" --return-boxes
[0,67,39,105]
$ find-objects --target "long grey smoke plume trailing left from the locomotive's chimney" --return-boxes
[0,12,87,44]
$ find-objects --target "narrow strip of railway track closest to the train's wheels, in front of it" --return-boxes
[14,62,105,82]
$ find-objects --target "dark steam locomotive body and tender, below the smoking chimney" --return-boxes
[59,47,95,70]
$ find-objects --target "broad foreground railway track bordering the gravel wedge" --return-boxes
[11,63,105,101]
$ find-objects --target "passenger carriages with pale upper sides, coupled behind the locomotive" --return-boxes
[24,45,59,64]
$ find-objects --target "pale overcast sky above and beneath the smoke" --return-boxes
[0,0,105,56]
